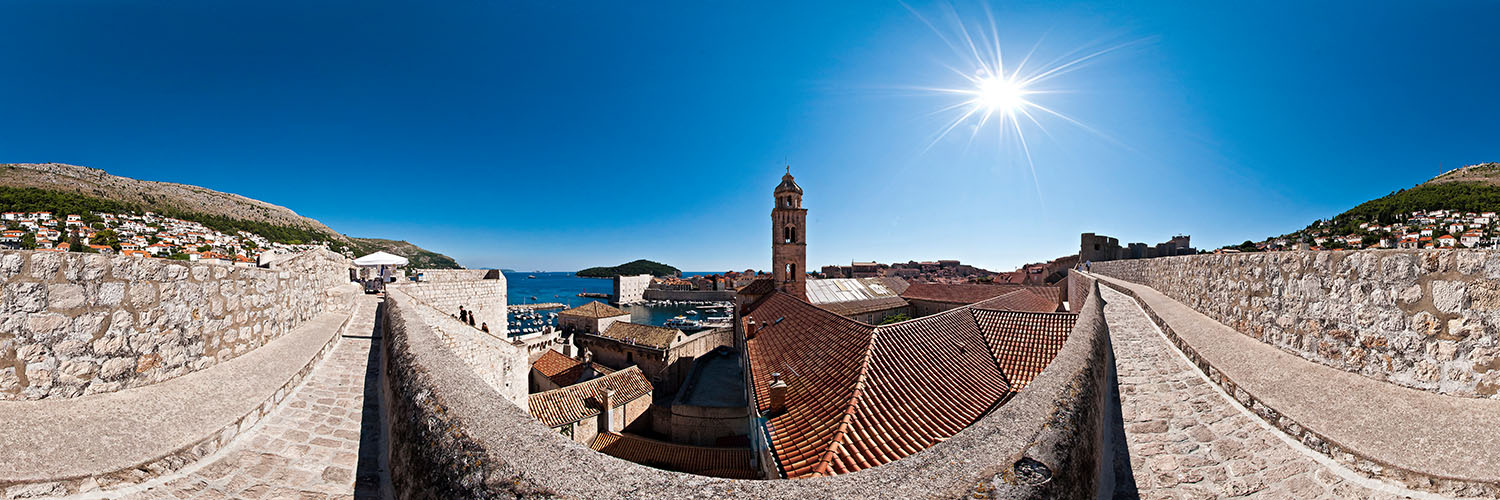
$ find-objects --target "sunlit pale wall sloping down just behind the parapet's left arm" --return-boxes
[390,287,531,408]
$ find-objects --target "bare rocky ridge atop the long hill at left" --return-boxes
[0,164,461,269]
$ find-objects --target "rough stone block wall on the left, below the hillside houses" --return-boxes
[0,249,357,399]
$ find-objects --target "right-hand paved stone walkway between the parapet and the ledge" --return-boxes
[1101,287,1431,498]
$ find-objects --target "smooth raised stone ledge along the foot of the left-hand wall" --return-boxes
[0,289,366,498]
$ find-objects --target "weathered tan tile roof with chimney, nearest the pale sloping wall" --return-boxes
[527,366,651,428]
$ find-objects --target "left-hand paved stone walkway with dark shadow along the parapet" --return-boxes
[126,296,389,498]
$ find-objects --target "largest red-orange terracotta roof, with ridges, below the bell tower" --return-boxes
[747,290,1076,477]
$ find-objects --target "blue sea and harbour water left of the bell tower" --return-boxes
[504,270,732,326]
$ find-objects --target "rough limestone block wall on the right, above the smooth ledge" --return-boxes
[1094,249,1500,398]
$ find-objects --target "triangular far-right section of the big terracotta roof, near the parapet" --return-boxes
[974,306,1079,392]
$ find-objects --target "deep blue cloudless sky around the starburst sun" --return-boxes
[0,2,1500,270]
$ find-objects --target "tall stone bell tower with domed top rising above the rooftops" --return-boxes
[771,167,807,300]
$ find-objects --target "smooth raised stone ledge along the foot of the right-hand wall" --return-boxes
[1095,276,1500,497]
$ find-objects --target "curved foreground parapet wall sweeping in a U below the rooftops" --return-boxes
[383,270,1113,498]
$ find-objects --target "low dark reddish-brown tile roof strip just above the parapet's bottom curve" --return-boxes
[588,432,758,479]
